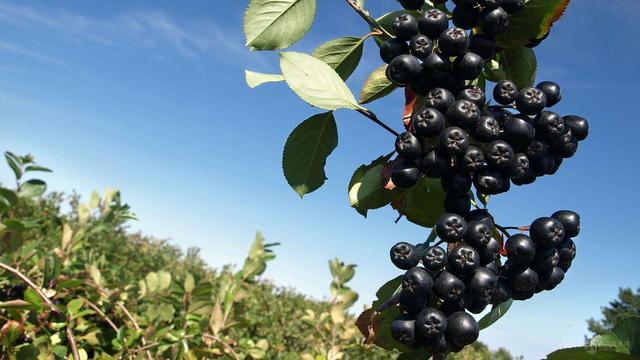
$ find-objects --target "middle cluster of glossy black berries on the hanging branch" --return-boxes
[391,80,589,197]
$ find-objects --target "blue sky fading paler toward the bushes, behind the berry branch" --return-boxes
[0,0,640,359]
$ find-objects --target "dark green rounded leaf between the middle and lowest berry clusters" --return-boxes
[391,177,446,228]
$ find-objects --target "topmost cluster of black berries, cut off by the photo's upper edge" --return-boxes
[380,0,524,95]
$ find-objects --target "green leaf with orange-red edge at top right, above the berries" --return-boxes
[496,0,569,48]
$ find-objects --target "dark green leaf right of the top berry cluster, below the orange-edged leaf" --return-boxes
[484,46,538,89]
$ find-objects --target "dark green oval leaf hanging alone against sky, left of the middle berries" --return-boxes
[282,112,338,197]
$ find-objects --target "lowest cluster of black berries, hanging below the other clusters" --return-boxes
[390,210,580,354]
